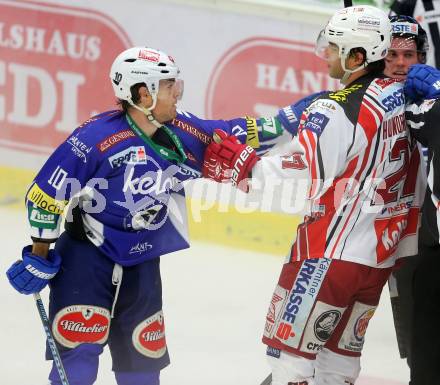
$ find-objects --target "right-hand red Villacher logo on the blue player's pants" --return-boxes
[132,310,167,358]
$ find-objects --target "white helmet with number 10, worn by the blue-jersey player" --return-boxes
[110,47,180,110]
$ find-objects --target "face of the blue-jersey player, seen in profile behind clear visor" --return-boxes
[153,79,183,123]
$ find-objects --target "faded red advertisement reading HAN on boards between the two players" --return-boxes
[205,38,339,118]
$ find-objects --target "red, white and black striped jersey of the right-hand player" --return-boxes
[252,75,424,268]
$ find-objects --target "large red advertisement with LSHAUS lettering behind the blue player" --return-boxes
[0,0,131,153]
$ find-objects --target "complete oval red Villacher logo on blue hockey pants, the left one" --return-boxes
[52,305,110,348]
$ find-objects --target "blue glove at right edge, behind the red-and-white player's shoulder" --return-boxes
[403,64,440,101]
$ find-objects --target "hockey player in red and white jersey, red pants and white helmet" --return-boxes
[203,6,423,385]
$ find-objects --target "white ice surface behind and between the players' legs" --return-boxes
[0,208,409,385]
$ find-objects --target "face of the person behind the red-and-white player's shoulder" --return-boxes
[384,37,419,80]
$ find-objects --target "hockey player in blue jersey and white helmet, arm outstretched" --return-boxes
[7,47,318,385]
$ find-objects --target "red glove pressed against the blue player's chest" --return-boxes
[202,129,260,192]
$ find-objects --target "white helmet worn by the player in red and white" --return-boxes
[316,5,391,72]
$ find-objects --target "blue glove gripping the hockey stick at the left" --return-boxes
[6,246,61,294]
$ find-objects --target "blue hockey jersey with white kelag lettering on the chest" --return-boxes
[26,111,287,266]
